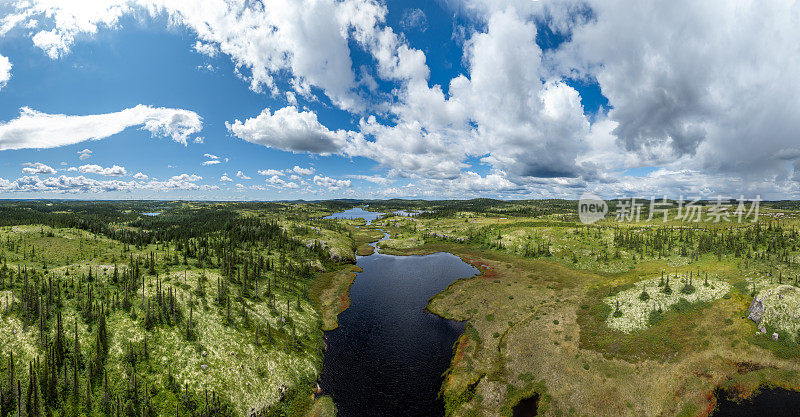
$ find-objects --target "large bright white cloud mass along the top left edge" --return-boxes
[0,0,386,109]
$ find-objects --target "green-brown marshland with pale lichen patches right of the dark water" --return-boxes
[370,200,800,416]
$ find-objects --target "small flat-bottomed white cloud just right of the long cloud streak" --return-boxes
[225,106,353,155]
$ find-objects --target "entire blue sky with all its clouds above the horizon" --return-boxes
[0,0,800,200]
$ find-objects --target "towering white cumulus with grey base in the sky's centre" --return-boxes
[345,8,590,179]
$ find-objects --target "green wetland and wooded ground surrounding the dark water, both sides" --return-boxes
[0,200,800,416]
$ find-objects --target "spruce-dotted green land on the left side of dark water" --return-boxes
[0,202,355,416]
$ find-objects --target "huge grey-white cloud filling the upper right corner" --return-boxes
[556,1,800,183]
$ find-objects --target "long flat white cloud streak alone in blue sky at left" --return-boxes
[0,105,202,150]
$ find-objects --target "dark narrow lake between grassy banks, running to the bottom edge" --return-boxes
[320,228,479,417]
